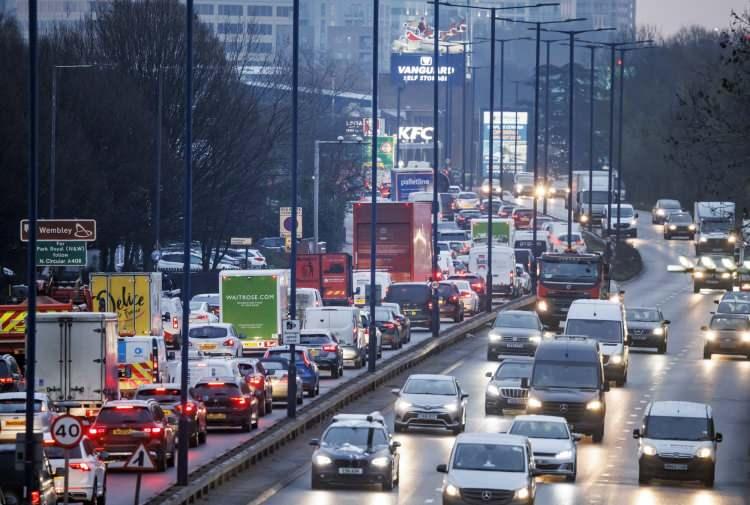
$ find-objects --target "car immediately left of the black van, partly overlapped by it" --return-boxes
[484,356,534,416]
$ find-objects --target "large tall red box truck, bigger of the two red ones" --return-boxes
[352,202,432,282]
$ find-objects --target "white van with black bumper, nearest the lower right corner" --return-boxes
[633,401,722,487]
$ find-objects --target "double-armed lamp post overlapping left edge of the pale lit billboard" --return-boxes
[442,2,560,312]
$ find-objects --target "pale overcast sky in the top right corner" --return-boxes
[636,0,750,35]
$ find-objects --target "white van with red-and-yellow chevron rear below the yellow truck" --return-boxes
[117,335,168,398]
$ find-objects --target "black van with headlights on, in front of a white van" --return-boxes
[521,335,609,443]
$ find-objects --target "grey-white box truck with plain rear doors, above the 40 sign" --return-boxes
[32,312,120,419]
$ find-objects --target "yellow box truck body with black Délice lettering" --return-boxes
[91,272,162,337]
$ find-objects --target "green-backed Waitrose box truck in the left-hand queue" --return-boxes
[219,270,290,354]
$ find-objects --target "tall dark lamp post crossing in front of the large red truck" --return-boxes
[368,0,378,372]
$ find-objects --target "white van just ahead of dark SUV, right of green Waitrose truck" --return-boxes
[304,307,367,368]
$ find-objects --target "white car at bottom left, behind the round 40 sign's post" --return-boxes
[44,437,107,504]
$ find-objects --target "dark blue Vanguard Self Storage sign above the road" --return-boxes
[391,53,465,84]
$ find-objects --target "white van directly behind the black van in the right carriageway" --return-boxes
[565,299,630,386]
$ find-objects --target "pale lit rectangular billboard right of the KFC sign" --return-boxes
[482,110,529,177]
